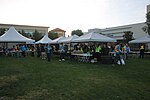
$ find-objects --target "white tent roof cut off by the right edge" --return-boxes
[129,35,150,43]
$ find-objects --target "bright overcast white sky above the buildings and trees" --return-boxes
[0,0,150,35]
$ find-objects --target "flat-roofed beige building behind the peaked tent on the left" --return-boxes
[0,24,49,34]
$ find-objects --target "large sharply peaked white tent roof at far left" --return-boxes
[0,26,35,43]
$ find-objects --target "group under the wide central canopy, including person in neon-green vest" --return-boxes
[73,43,130,64]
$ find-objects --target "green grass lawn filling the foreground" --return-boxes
[0,57,150,100]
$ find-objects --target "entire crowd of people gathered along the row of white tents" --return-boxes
[1,43,145,65]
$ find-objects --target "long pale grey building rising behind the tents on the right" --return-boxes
[88,22,147,40]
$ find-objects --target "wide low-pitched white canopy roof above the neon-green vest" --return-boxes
[72,32,116,42]
